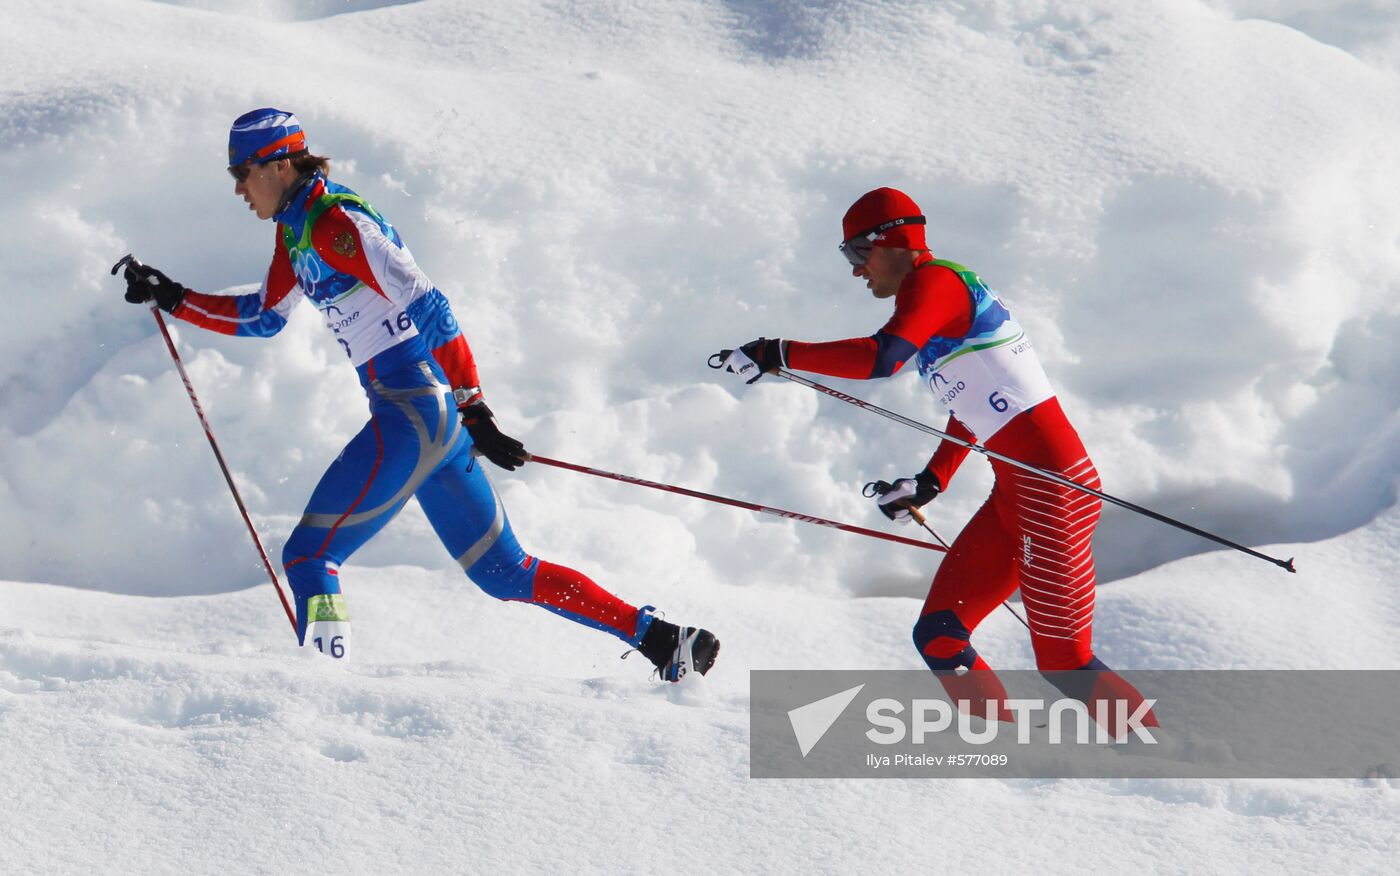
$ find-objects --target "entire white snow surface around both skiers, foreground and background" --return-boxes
[0,0,1400,873]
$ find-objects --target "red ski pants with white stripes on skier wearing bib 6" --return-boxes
[916,446,1100,670]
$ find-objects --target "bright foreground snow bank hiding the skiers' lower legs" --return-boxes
[0,500,1400,873]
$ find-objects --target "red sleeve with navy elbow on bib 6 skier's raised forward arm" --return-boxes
[787,264,972,381]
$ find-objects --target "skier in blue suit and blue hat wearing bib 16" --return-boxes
[114,108,720,681]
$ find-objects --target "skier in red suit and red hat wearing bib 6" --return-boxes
[725,188,1153,722]
